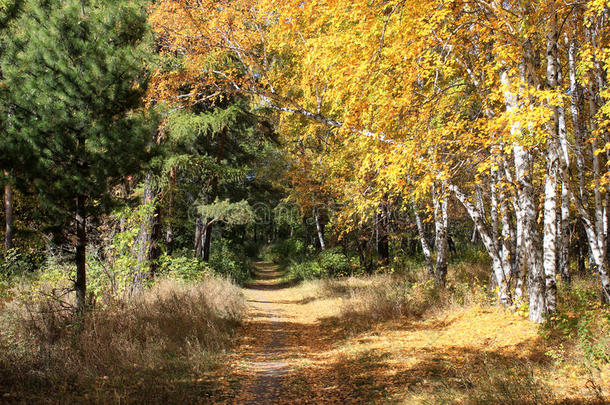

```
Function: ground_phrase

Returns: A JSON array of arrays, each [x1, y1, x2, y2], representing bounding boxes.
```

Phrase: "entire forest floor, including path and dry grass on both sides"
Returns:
[[0, 262, 610, 405]]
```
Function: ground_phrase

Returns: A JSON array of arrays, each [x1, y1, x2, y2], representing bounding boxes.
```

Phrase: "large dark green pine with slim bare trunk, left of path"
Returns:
[[2, 0, 155, 312]]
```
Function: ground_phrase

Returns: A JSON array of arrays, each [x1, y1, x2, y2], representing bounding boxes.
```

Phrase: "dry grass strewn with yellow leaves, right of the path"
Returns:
[[280, 265, 610, 405]]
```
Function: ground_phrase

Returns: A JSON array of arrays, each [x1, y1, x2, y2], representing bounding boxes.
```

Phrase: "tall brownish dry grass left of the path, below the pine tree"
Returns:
[[0, 277, 245, 403]]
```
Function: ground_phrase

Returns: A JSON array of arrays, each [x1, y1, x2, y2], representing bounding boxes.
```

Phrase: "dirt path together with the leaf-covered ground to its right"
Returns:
[[214, 263, 610, 404]]
